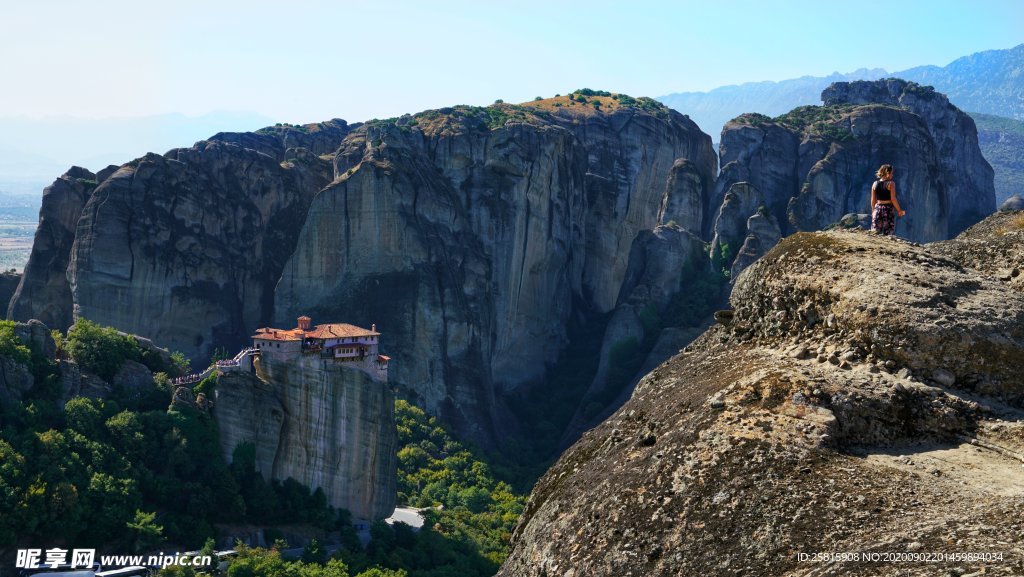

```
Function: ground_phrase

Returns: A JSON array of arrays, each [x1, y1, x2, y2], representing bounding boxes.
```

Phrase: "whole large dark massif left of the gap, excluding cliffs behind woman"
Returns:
[[18, 96, 717, 437]]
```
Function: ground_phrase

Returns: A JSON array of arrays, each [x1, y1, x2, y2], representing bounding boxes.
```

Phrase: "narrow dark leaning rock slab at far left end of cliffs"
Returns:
[[7, 166, 99, 330]]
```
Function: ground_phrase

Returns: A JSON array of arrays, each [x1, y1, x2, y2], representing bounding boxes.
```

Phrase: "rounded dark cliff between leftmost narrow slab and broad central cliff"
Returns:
[[68, 140, 330, 361]]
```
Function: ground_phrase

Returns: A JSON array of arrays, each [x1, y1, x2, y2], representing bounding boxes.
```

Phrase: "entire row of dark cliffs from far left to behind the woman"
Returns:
[[9, 81, 994, 444]]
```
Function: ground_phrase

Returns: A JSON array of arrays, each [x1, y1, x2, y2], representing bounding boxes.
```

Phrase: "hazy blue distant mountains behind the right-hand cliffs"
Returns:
[[657, 44, 1024, 141]]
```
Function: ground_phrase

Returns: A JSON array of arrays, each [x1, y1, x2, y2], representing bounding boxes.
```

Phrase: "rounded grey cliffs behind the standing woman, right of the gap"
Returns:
[[708, 79, 995, 276]]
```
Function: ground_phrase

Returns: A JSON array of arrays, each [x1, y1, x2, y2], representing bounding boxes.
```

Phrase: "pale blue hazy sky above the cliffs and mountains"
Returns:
[[0, 0, 1024, 122]]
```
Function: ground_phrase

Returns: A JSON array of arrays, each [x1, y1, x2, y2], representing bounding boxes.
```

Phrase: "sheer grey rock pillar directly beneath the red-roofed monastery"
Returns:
[[214, 355, 397, 520]]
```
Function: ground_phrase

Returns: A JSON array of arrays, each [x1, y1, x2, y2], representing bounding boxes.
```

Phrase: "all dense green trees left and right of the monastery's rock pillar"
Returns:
[[0, 321, 524, 577]]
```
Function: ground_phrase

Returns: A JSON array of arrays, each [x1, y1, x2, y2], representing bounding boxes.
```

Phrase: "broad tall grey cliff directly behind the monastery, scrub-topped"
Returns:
[[274, 98, 716, 428]]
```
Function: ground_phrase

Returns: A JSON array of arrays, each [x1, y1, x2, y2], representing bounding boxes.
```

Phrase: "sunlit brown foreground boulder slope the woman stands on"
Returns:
[[500, 213, 1024, 577]]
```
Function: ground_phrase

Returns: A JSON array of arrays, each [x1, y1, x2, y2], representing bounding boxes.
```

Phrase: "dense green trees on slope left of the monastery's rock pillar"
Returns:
[[0, 321, 339, 550]]
